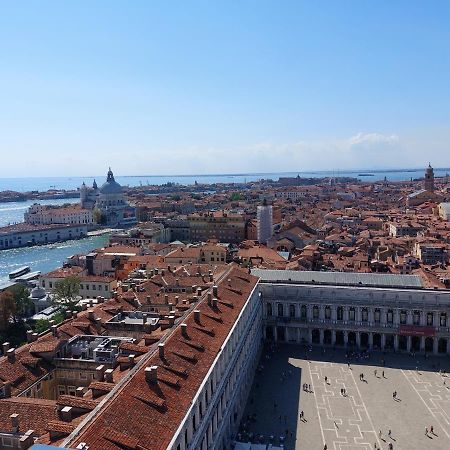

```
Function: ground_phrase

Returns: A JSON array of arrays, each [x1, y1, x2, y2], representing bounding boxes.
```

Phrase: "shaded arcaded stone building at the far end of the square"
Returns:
[[252, 270, 450, 354]]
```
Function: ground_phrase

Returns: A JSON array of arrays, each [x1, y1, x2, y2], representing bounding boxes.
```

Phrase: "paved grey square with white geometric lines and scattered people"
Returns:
[[240, 345, 450, 450]]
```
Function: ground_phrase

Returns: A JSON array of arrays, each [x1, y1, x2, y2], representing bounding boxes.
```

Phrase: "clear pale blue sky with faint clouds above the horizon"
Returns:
[[0, 0, 450, 177]]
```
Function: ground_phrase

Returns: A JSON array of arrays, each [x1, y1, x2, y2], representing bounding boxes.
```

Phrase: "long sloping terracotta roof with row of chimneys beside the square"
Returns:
[[70, 269, 257, 450]]
